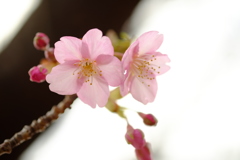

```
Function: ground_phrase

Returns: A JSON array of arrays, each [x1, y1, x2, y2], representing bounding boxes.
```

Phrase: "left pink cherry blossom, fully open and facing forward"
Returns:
[[46, 29, 123, 108]]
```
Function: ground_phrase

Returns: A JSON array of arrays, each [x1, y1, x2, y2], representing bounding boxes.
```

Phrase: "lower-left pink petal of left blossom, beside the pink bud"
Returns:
[[46, 62, 83, 95]]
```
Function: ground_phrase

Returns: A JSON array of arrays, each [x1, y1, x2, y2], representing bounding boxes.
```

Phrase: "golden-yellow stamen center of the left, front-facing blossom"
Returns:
[[73, 58, 102, 85]]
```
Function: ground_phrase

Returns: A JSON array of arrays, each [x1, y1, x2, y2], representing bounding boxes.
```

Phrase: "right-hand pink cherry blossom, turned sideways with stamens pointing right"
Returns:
[[121, 31, 170, 104]]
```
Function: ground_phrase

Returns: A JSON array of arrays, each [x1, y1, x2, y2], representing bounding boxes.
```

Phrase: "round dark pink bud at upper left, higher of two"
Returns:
[[33, 32, 50, 51]]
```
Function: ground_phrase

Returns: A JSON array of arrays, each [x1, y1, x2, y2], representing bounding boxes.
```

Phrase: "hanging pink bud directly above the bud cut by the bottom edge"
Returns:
[[125, 124, 146, 149]]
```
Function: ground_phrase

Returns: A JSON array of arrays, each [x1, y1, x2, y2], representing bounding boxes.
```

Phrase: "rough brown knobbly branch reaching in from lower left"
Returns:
[[0, 95, 77, 156]]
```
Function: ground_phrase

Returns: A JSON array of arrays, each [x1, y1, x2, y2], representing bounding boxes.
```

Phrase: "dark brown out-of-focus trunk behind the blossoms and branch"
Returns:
[[0, 0, 139, 160]]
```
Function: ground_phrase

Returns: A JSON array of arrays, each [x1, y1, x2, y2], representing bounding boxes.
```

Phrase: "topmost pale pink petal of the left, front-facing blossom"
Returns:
[[82, 29, 114, 60]]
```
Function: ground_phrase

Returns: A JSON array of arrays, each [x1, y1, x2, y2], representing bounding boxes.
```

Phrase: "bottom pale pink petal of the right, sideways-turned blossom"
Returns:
[[130, 77, 158, 104]]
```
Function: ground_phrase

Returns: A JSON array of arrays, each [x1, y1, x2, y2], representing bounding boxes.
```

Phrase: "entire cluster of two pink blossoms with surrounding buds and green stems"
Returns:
[[29, 29, 170, 160]]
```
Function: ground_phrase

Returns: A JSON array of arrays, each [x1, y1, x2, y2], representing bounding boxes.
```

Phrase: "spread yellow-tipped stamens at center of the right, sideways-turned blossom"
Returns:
[[132, 55, 160, 87]]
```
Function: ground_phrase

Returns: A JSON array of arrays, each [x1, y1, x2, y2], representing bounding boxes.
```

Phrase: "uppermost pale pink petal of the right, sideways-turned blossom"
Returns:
[[136, 31, 163, 55]]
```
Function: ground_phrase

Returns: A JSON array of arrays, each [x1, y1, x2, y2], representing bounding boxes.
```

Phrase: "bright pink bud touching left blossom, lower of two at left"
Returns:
[[28, 65, 47, 83]]
